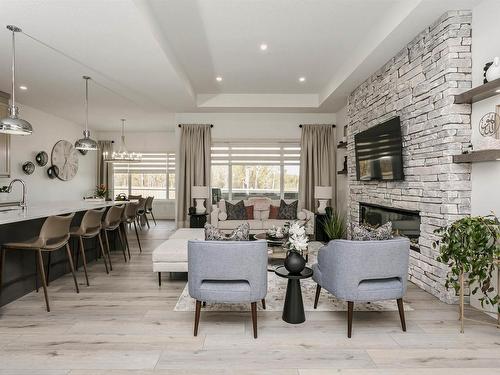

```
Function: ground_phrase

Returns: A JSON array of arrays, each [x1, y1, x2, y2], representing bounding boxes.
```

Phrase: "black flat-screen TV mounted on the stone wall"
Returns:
[[354, 117, 404, 181]]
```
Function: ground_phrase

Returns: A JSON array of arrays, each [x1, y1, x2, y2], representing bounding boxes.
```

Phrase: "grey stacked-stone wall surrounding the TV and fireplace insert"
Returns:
[[347, 11, 472, 302]]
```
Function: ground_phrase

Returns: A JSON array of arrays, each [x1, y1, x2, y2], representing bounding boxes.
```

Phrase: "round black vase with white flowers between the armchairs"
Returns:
[[283, 221, 309, 273]]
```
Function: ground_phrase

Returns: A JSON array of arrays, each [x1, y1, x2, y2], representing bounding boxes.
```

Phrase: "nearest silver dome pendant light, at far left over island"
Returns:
[[0, 25, 33, 135]]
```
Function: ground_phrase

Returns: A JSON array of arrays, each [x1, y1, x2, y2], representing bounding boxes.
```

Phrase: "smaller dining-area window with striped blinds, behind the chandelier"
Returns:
[[113, 153, 175, 199]]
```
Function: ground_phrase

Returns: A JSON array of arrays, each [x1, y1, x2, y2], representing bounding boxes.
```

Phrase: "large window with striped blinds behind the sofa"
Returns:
[[211, 142, 300, 199]]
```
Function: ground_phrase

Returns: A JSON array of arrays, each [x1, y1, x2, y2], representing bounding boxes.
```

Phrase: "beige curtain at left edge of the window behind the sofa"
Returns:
[[177, 124, 212, 228]]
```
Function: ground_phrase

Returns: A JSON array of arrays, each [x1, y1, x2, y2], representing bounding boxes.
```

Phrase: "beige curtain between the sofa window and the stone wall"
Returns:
[[299, 124, 336, 212]]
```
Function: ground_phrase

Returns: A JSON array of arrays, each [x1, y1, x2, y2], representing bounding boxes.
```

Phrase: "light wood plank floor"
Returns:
[[0, 221, 500, 375]]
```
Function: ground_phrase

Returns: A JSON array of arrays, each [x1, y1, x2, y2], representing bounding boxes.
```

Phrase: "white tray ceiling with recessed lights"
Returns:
[[0, 0, 479, 130]]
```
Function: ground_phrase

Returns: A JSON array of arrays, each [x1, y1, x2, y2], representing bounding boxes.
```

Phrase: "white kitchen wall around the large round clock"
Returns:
[[0, 105, 96, 203]]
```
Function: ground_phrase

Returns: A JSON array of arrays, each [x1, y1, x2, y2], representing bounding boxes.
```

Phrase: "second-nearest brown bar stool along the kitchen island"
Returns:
[[69, 207, 109, 286]]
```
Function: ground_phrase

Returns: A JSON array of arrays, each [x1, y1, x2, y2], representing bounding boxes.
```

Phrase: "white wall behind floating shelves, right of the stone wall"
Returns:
[[471, 0, 500, 316]]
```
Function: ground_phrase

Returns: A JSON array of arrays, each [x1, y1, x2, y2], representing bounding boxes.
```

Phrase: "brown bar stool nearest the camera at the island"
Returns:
[[0, 213, 80, 312]]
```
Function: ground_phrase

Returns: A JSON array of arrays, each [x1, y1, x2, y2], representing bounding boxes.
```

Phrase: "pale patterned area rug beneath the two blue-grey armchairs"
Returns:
[[174, 242, 413, 311]]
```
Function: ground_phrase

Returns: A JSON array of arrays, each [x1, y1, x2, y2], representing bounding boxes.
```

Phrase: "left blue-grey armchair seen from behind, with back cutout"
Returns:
[[188, 241, 267, 338]]
